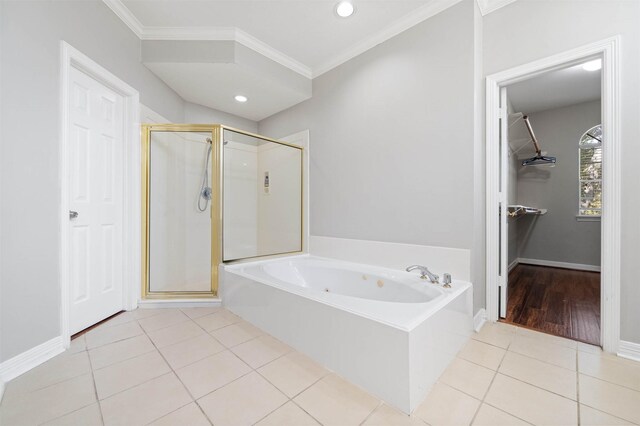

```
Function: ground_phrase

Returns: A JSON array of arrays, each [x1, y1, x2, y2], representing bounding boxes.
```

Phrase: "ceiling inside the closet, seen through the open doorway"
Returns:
[[507, 60, 601, 114]]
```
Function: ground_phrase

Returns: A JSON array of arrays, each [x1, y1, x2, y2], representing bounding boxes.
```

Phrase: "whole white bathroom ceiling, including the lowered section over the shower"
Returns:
[[103, 0, 515, 121]]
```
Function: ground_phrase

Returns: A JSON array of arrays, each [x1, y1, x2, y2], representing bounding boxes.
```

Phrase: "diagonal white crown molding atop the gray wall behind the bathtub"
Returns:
[[313, 0, 462, 78]]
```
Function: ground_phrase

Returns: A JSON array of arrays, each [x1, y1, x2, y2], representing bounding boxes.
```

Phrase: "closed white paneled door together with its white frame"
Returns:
[[60, 41, 139, 347]]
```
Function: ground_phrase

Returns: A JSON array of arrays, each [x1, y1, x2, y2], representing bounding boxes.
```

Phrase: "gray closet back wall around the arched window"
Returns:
[[509, 101, 606, 266]]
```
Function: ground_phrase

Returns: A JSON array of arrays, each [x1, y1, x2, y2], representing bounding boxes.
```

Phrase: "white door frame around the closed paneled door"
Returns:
[[59, 40, 141, 348]]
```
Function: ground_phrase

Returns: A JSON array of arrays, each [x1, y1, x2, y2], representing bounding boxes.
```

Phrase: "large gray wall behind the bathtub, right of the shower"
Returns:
[[259, 0, 475, 251]]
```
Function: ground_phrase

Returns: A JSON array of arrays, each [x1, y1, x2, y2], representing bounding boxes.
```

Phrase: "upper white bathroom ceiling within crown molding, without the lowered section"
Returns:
[[122, 0, 451, 74]]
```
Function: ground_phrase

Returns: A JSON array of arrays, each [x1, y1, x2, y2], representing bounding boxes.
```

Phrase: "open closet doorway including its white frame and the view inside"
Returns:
[[486, 38, 620, 352]]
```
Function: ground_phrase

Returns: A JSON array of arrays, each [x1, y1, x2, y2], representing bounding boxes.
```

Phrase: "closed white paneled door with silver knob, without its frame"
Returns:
[[68, 67, 124, 334]]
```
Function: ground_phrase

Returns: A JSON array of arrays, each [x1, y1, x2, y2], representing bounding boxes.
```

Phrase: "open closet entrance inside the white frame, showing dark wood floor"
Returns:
[[500, 65, 603, 345]]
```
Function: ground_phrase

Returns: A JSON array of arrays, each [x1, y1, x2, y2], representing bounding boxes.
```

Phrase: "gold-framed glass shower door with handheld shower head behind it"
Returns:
[[143, 125, 219, 298]]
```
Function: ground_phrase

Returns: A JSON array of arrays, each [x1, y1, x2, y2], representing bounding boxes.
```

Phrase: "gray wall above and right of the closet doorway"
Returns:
[[483, 0, 640, 342]]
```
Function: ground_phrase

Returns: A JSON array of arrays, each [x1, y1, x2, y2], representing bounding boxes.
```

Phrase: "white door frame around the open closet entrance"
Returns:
[[485, 35, 622, 353]]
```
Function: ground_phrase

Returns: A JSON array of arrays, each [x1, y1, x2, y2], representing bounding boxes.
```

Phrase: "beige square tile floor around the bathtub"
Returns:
[[0, 308, 640, 426]]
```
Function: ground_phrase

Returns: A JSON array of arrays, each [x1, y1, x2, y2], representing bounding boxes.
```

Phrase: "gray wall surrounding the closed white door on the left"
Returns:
[[0, 1, 178, 361]]
